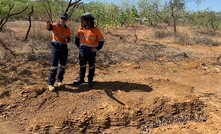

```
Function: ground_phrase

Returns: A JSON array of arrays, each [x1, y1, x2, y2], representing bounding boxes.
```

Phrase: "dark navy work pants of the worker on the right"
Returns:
[[79, 46, 96, 82]]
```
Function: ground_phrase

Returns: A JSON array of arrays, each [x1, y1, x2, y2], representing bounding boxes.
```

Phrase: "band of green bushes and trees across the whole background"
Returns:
[[0, 0, 221, 30]]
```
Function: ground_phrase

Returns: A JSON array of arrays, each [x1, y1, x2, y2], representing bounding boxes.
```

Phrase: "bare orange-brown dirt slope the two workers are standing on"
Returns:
[[0, 23, 221, 134]]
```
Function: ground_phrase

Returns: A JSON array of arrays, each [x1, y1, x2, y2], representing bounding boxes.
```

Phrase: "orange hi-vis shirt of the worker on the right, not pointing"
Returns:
[[76, 27, 104, 47]]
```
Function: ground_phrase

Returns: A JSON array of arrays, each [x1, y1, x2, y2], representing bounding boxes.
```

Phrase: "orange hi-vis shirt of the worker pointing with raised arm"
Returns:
[[52, 23, 71, 44]]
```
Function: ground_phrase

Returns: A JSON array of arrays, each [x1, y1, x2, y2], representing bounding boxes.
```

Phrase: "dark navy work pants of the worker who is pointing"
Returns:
[[48, 44, 68, 85]]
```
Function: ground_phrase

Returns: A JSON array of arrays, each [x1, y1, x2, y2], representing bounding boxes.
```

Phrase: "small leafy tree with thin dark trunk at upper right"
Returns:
[[138, 0, 201, 33]]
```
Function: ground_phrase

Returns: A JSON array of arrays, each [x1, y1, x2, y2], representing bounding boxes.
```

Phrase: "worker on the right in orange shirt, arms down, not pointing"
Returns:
[[73, 13, 104, 87]]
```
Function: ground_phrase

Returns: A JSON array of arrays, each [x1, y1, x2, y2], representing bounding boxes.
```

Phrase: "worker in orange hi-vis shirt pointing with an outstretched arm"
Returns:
[[46, 13, 71, 91]]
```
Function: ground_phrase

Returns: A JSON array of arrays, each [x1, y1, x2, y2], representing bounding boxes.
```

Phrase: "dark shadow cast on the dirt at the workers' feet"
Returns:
[[57, 81, 153, 105]]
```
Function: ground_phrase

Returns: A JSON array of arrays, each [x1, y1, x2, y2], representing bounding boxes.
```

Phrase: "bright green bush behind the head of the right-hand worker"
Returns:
[[80, 2, 138, 27]]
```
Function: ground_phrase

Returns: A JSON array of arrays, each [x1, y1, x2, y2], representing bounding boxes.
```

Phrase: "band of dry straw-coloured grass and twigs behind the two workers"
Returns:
[[1, 22, 220, 65]]
